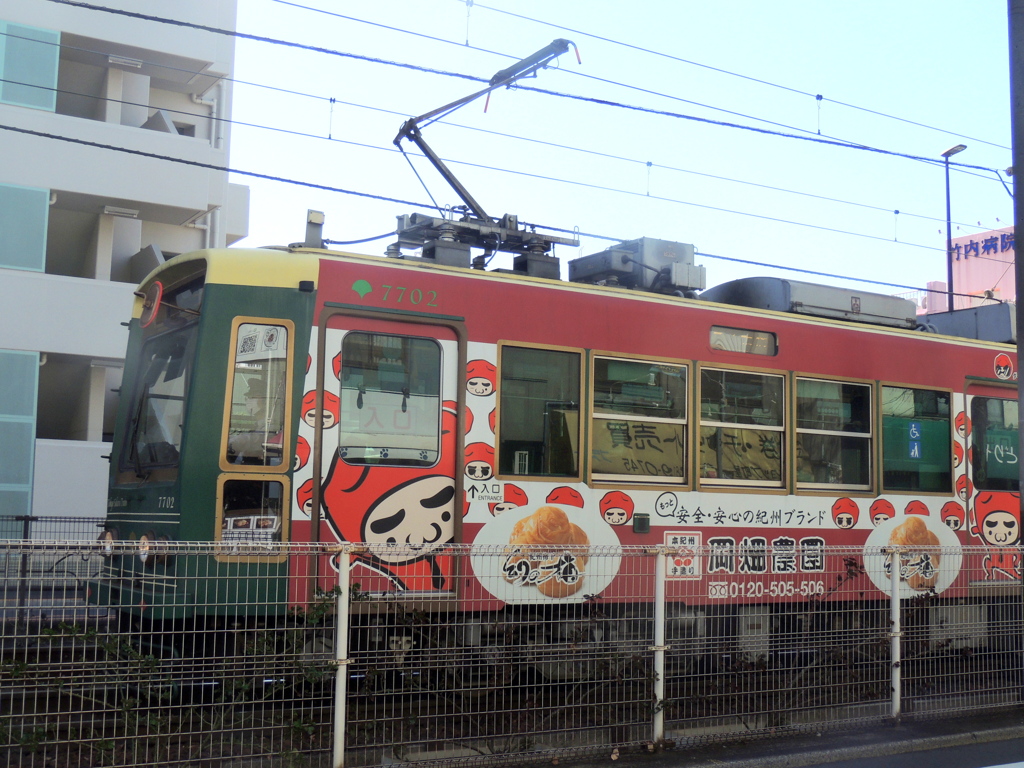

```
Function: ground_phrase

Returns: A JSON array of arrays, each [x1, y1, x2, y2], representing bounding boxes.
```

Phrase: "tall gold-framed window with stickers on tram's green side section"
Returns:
[[224, 323, 289, 467]]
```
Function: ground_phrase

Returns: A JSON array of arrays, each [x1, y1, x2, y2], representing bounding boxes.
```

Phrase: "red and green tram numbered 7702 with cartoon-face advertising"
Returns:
[[89, 215, 1021, 667]]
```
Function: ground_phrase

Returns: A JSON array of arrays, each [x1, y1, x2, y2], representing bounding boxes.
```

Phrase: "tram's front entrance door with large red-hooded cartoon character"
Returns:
[[322, 315, 461, 592]]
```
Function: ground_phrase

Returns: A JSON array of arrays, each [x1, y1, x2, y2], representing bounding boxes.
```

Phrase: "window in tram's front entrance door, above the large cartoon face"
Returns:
[[338, 331, 441, 467]]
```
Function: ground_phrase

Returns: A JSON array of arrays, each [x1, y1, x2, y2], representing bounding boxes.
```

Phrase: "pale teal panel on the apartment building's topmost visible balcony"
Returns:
[[0, 22, 60, 112]]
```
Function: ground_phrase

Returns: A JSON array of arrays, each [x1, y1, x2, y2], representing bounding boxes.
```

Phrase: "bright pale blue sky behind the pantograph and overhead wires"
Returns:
[[230, 0, 1013, 293]]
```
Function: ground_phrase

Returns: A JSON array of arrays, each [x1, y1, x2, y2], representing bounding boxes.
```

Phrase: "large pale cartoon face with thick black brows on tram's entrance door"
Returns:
[[362, 475, 455, 565]]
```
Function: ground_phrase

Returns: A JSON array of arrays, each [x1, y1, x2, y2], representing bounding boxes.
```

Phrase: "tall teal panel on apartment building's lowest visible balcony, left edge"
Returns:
[[0, 349, 39, 517]]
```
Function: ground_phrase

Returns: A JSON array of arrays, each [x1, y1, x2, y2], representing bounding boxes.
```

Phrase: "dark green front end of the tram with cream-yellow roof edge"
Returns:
[[89, 250, 315, 622]]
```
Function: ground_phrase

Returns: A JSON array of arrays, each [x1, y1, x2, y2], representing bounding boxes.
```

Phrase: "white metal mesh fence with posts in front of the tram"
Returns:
[[0, 538, 1022, 768]]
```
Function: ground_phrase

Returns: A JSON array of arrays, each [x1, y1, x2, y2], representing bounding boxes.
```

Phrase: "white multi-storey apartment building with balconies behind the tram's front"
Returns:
[[0, 0, 249, 536]]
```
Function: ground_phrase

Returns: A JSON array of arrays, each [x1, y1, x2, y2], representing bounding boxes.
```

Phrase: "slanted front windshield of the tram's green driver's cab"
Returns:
[[121, 323, 198, 474]]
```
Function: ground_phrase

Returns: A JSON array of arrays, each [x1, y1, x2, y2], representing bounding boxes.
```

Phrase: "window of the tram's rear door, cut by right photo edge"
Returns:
[[971, 397, 1020, 492]]
